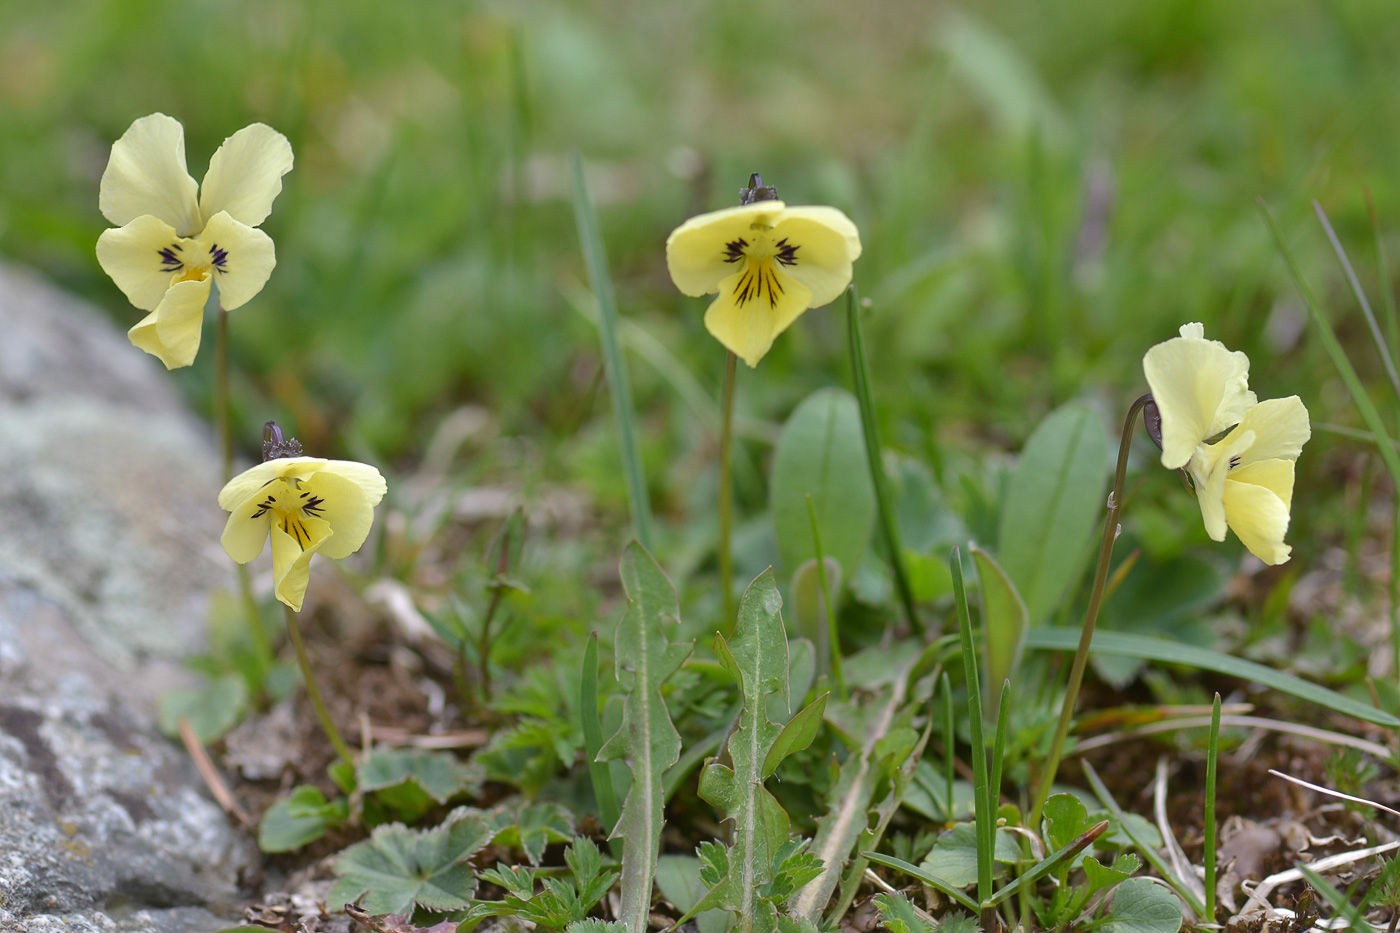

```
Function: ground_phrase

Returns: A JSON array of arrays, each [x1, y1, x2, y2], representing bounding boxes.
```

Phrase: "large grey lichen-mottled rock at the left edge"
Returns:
[[0, 265, 258, 933]]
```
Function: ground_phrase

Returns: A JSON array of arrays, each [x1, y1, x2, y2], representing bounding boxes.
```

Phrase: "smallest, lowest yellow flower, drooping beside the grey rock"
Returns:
[[218, 457, 386, 612]]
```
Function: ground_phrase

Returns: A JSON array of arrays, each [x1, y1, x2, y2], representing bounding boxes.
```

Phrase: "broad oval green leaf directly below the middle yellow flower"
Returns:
[[770, 388, 875, 580]]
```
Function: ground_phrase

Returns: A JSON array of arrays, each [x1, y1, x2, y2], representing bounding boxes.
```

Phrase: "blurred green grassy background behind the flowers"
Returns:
[[0, 0, 1400, 574]]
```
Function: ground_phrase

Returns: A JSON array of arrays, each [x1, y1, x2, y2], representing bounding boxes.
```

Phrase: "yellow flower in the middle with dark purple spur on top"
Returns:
[[666, 175, 861, 367]]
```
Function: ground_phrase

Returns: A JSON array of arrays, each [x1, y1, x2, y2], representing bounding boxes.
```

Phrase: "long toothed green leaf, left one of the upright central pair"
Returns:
[[598, 542, 692, 933]]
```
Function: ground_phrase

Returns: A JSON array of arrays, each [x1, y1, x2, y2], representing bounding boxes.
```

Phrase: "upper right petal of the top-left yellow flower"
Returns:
[[199, 123, 293, 228]]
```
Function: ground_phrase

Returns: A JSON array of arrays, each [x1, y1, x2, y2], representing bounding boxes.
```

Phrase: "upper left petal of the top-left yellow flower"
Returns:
[[98, 113, 204, 237]]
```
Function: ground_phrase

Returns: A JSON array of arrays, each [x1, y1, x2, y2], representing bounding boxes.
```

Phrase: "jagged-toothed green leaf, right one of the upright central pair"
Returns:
[[696, 570, 825, 933]]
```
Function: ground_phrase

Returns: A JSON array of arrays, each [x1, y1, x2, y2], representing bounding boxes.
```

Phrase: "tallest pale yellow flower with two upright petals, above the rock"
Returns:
[[97, 113, 293, 370]]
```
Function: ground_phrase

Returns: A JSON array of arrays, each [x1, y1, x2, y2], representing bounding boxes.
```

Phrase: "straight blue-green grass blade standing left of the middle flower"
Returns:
[[568, 153, 652, 551]]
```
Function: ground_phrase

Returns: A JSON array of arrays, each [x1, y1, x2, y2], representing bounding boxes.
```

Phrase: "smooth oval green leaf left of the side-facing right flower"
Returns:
[[997, 405, 1109, 624]]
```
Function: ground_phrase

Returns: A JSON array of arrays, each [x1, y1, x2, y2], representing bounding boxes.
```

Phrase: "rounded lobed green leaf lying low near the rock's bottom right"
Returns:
[[326, 807, 491, 915]]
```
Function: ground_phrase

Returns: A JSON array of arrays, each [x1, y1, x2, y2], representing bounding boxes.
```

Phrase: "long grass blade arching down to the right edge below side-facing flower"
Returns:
[[1026, 626, 1400, 728]]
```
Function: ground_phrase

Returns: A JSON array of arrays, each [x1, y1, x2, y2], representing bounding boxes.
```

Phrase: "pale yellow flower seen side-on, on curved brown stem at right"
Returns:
[[1142, 324, 1312, 565]]
